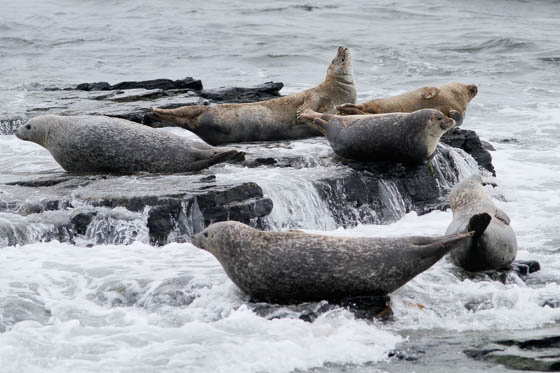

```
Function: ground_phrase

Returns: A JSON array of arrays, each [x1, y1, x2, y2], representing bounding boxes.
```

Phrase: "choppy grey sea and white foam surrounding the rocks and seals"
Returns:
[[0, 0, 560, 372]]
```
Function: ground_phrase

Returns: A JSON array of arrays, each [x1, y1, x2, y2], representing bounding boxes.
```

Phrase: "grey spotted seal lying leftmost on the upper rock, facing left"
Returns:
[[16, 115, 244, 173]]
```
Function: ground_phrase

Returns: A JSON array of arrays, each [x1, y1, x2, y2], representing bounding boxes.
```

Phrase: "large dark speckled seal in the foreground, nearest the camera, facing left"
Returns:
[[192, 221, 473, 304]]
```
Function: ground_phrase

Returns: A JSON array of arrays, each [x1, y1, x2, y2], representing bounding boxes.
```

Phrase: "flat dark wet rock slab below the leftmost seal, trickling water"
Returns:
[[0, 175, 272, 245]]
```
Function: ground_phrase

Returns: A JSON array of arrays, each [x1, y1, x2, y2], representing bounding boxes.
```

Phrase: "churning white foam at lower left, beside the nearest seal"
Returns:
[[0, 242, 402, 372]]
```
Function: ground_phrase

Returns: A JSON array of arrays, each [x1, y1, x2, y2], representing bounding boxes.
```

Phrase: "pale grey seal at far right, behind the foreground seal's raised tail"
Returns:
[[447, 174, 517, 271]]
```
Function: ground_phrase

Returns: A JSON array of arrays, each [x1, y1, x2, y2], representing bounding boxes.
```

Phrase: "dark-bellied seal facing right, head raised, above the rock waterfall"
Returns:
[[301, 109, 455, 164]]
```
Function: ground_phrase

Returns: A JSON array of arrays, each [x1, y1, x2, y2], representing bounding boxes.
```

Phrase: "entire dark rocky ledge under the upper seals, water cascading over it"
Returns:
[[0, 78, 493, 246]]
